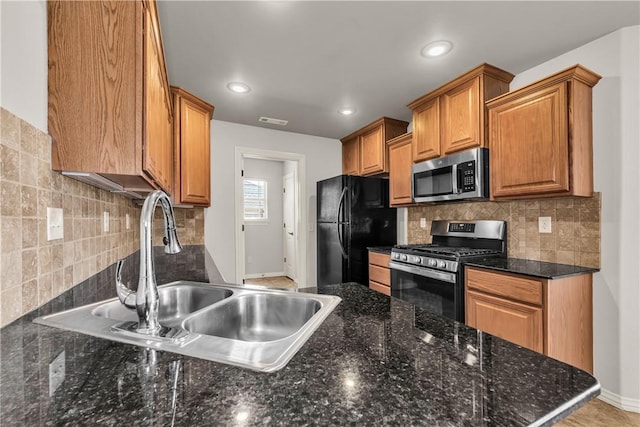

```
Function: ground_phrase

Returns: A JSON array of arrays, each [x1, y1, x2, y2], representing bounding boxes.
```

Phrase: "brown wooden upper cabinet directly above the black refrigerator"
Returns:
[[341, 117, 409, 176]]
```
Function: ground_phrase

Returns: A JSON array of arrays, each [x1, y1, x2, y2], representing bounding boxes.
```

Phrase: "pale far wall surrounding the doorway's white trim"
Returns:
[[204, 120, 342, 286]]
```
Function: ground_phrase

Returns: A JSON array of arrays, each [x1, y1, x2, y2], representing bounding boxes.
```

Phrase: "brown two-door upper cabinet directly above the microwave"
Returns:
[[407, 64, 514, 162]]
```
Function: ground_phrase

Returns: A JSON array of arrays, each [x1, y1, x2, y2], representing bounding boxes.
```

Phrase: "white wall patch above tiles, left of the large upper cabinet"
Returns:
[[0, 0, 47, 132]]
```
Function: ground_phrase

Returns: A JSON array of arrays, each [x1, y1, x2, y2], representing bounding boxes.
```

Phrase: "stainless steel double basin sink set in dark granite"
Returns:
[[34, 281, 341, 372]]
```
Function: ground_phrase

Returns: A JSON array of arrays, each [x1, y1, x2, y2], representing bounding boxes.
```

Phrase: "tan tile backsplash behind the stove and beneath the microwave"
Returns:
[[407, 193, 602, 268]]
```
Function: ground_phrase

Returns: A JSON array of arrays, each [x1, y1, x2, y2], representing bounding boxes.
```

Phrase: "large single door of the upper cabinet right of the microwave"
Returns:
[[489, 83, 570, 199]]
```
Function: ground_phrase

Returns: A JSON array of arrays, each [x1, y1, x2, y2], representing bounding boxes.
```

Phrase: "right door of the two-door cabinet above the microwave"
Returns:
[[441, 77, 484, 154]]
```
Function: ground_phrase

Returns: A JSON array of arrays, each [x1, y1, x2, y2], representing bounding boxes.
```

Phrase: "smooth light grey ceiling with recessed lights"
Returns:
[[158, 0, 640, 139]]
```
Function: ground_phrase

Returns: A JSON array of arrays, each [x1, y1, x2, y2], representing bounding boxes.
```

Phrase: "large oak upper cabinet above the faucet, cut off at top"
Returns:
[[47, 0, 173, 197]]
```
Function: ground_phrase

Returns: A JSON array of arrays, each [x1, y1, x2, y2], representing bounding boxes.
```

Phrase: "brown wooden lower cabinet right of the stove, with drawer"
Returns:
[[465, 267, 593, 373]]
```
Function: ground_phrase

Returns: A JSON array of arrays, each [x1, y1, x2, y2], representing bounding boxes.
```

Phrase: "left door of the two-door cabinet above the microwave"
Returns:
[[413, 98, 440, 162]]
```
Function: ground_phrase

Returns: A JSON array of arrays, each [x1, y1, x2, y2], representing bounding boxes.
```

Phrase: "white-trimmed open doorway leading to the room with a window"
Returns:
[[235, 147, 307, 288]]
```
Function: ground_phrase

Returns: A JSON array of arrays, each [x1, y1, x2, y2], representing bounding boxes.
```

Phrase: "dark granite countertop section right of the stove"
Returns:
[[465, 258, 600, 279]]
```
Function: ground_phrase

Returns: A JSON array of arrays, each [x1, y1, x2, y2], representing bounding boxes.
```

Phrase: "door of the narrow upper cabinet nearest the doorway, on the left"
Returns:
[[176, 98, 211, 206]]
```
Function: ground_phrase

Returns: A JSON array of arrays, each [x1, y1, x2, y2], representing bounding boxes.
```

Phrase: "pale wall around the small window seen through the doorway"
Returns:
[[244, 159, 284, 275]]
